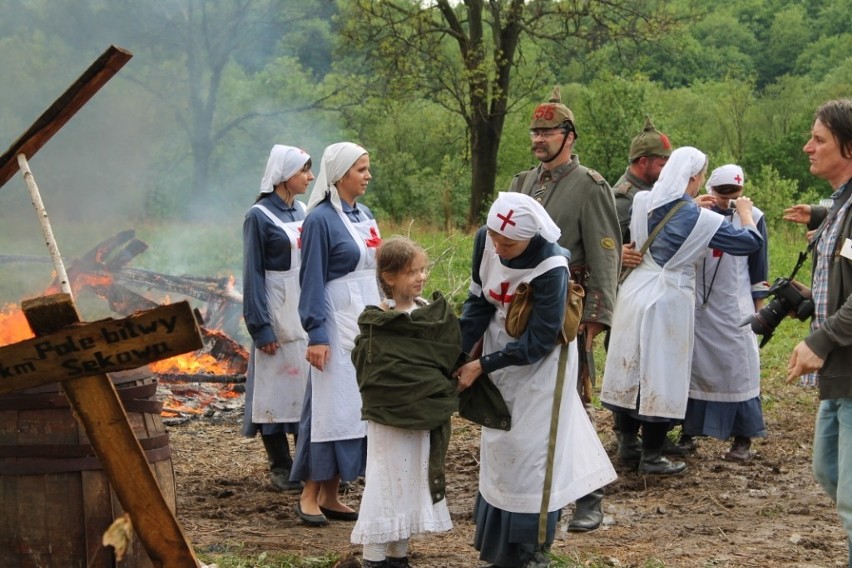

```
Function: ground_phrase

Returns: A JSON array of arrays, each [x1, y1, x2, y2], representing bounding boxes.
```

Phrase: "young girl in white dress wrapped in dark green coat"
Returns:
[[351, 238, 461, 568]]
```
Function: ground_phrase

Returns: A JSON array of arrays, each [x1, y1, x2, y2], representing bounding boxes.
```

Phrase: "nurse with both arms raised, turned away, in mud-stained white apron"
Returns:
[[600, 146, 763, 475]]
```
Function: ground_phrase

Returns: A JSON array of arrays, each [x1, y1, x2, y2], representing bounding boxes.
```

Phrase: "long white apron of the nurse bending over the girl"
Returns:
[[479, 238, 616, 513]]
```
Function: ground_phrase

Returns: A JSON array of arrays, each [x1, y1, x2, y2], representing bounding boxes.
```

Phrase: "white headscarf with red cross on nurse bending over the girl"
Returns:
[[487, 191, 562, 243]]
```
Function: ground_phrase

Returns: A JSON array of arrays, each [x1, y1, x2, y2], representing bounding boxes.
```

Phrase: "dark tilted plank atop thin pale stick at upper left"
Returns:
[[0, 45, 133, 187]]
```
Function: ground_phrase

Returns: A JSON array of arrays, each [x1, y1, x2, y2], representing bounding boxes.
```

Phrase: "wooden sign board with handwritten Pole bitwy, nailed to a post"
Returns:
[[0, 301, 203, 394]]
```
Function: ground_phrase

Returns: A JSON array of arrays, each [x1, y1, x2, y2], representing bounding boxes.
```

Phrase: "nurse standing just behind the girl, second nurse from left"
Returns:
[[291, 142, 381, 526]]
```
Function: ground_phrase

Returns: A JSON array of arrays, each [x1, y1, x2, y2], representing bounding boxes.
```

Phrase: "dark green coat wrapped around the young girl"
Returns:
[[352, 292, 462, 502]]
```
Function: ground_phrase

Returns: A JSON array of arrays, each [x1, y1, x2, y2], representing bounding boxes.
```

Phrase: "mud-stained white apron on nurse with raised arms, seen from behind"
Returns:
[[600, 191, 724, 419]]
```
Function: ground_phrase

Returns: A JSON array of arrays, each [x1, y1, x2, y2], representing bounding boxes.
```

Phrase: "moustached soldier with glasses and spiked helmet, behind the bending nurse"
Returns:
[[510, 87, 621, 532]]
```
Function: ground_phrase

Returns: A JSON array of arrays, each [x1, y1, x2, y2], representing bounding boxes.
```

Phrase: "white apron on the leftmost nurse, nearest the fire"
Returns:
[[251, 202, 310, 424]]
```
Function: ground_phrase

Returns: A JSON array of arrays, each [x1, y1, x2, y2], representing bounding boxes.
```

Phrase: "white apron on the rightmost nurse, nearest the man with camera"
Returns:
[[689, 208, 763, 402]]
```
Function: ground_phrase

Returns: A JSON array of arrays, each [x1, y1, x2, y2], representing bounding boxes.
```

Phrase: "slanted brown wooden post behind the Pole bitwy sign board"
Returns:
[[22, 294, 200, 568]]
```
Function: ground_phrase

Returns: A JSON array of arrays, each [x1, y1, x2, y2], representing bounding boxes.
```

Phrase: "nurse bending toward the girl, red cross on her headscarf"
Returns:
[[457, 192, 615, 568]]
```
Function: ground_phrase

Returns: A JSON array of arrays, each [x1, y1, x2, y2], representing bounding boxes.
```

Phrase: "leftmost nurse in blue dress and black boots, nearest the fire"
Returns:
[[243, 144, 314, 491]]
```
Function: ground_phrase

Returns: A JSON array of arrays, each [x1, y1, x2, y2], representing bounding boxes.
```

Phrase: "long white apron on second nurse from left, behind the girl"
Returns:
[[311, 211, 381, 442]]
